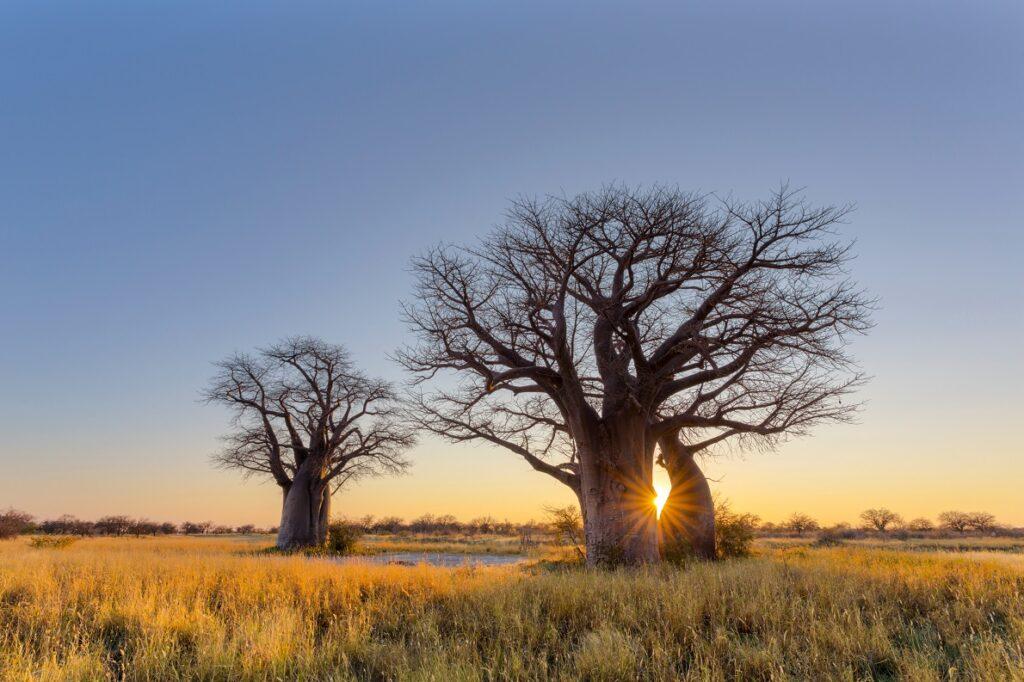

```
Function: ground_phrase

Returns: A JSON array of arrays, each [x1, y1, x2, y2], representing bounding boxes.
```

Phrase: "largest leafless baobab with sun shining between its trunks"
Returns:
[[398, 187, 870, 564]]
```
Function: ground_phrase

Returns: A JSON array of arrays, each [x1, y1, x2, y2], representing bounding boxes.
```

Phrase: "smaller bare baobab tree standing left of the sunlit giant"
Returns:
[[205, 337, 414, 549]]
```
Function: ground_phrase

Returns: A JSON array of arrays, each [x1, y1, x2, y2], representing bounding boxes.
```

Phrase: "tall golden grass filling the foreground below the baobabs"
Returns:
[[0, 539, 1024, 680]]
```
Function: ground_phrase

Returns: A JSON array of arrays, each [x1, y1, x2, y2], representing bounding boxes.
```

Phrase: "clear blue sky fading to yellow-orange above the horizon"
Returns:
[[0, 0, 1024, 524]]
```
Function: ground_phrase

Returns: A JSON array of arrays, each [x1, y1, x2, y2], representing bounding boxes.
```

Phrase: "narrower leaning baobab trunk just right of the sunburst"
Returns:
[[659, 436, 716, 559]]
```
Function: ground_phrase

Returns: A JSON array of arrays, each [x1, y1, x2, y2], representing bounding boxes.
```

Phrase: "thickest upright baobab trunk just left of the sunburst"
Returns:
[[580, 416, 660, 566]]
